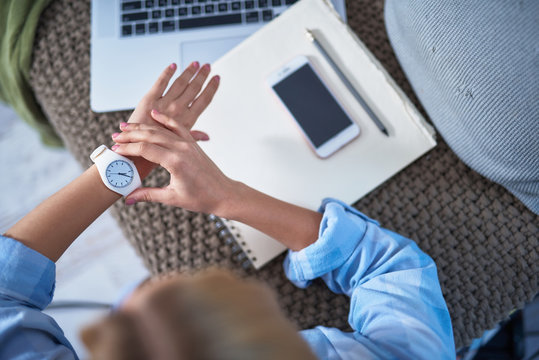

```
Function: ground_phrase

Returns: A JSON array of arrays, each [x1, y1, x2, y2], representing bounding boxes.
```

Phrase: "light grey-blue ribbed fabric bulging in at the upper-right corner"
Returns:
[[385, 0, 539, 214]]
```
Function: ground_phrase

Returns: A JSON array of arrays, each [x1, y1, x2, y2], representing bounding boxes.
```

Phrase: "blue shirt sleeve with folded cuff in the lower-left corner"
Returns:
[[0, 236, 77, 359]]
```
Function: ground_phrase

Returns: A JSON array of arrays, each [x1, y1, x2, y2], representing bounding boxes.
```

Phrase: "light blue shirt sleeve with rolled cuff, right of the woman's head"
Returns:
[[284, 199, 455, 359]]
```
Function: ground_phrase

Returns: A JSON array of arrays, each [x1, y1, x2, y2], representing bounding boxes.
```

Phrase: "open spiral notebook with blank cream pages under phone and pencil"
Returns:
[[195, 0, 436, 269]]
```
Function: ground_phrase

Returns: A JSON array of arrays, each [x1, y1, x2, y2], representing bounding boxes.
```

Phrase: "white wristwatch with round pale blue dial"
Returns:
[[90, 145, 142, 196]]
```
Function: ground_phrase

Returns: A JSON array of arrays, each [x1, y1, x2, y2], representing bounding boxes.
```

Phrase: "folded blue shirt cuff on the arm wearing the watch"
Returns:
[[0, 236, 56, 310]]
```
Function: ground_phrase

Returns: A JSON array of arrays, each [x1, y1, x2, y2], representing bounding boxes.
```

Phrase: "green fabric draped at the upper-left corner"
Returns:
[[0, 0, 63, 146]]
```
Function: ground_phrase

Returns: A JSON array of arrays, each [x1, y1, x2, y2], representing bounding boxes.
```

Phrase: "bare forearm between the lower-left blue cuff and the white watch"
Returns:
[[5, 165, 120, 261]]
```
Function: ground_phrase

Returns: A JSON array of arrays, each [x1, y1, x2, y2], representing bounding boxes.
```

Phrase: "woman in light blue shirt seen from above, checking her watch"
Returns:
[[0, 62, 455, 359]]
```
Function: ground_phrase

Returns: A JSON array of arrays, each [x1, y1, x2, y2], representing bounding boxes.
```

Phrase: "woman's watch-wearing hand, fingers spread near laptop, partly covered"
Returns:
[[124, 61, 220, 178]]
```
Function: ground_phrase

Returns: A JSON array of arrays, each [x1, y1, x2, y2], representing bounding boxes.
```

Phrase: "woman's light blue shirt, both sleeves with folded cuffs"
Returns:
[[0, 199, 455, 359]]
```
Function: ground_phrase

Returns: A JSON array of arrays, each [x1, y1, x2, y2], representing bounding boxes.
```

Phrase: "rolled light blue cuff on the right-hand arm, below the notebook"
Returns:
[[284, 198, 378, 287]]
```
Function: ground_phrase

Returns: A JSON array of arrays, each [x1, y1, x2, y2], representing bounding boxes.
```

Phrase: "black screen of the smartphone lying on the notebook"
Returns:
[[273, 64, 352, 147]]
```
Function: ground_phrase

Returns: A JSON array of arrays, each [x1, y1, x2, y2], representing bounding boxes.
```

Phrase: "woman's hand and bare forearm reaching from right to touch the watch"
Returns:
[[112, 110, 322, 251]]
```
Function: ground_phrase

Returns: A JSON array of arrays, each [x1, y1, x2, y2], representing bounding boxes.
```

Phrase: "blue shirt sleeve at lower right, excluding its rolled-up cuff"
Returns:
[[342, 228, 455, 359]]
